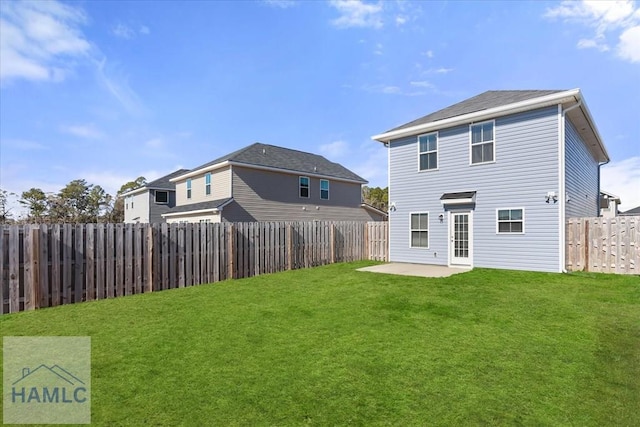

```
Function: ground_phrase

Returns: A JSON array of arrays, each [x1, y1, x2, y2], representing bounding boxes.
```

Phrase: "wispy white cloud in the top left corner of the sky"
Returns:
[[0, 1, 92, 81]]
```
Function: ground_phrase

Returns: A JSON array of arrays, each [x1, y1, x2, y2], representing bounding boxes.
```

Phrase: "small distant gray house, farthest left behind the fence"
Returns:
[[120, 169, 188, 223]]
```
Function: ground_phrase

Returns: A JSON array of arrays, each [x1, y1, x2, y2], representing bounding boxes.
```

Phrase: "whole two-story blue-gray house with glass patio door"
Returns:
[[373, 89, 609, 272]]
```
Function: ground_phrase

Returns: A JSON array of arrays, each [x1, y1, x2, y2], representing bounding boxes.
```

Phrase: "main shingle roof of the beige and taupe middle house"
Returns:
[[192, 142, 367, 184]]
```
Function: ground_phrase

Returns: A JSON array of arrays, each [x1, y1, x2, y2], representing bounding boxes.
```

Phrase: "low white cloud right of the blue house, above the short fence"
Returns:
[[600, 156, 640, 211]]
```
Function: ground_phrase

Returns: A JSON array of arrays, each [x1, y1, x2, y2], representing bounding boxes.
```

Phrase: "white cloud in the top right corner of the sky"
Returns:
[[544, 0, 640, 62]]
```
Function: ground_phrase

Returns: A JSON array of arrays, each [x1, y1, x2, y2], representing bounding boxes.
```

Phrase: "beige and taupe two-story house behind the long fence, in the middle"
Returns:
[[162, 143, 386, 223]]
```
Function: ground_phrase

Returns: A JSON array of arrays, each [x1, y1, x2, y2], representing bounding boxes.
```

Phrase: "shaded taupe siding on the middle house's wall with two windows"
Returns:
[[222, 166, 380, 222]]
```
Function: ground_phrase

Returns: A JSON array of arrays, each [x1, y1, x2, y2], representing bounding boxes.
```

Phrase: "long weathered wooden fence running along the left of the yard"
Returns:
[[0, 222, 387, 314]]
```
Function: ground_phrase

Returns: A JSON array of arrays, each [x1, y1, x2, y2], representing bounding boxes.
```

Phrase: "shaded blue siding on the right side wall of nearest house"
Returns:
[[565, 119, 600, 218]]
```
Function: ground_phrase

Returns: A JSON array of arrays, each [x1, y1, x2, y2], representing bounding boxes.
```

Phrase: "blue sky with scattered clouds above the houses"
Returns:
[[0, 0, 640, 214]]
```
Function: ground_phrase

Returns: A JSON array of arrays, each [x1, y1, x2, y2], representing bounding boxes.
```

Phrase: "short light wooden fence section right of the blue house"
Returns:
[[566, 216, 640, 274]]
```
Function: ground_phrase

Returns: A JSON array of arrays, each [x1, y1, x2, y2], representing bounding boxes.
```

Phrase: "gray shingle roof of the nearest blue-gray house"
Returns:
[[387, 90, 564, 132]]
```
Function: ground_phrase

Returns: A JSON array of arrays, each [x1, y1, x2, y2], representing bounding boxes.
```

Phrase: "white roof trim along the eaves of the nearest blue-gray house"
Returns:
[[371, 89, 584, 143]]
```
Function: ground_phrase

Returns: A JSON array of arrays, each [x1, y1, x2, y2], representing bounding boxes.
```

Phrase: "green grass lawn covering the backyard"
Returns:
[[0, 262, 640, 426]]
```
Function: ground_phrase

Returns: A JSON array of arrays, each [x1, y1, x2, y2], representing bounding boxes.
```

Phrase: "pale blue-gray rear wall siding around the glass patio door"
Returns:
[[389, 107, 560, 271]]
